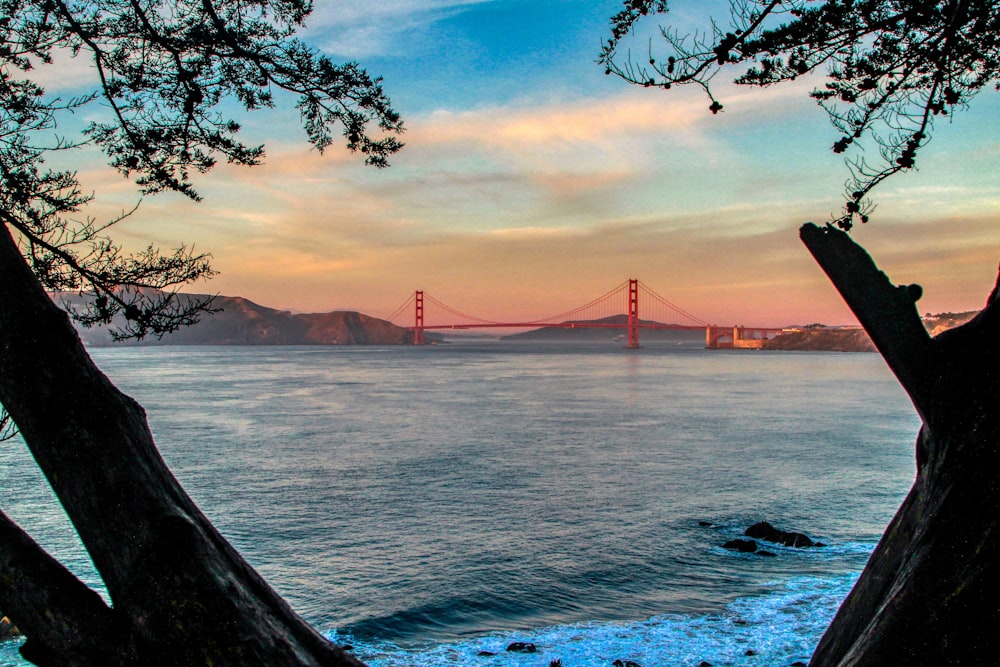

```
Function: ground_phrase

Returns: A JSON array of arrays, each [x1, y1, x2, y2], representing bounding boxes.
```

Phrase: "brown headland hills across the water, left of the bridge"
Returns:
[[54, 294, 441, 346]]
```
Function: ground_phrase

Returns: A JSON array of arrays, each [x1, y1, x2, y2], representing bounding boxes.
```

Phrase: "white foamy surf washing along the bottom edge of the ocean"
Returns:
[[331, 574, 857, 667]]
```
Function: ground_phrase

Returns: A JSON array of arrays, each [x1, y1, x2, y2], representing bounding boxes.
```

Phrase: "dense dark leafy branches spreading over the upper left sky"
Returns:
[[0, 0, 403, 338]]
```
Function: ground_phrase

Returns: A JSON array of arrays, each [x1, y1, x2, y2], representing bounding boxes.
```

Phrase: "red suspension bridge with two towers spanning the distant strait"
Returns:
[[386, 278, 782, 349]]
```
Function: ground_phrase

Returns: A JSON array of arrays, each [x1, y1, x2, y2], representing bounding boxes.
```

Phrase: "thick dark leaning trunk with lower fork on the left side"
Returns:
[[0, 222, 361, 667]]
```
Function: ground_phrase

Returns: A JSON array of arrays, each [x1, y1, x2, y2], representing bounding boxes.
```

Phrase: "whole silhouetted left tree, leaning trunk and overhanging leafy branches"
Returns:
[[0, 0, 403, 666]]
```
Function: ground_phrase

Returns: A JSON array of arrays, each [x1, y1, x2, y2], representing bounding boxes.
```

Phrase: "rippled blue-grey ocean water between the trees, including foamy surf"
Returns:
[[0, 341, 919, 667]]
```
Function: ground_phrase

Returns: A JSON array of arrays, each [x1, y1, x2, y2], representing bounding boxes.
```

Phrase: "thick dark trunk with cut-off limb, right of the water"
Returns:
[[801, 225, 1000, 667]]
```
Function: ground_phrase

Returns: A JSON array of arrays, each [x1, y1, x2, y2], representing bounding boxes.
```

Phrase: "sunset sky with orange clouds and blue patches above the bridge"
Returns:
[[37, 0, 1000, 326]]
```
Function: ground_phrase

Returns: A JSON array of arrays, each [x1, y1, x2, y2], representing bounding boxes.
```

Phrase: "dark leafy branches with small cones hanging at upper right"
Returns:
[[600, 0, 1000, 230]]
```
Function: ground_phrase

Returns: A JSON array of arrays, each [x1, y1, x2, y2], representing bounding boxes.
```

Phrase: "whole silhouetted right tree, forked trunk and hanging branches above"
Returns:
[[600, 0, 1000, 665]]
